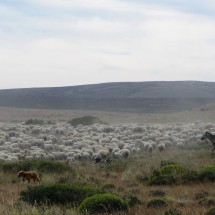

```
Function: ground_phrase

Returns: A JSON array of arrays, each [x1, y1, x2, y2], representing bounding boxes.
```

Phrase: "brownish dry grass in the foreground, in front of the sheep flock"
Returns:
[[0, 141, 215, 215]]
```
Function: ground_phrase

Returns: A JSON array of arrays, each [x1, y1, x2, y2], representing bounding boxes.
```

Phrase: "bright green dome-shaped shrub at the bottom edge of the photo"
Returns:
[[78, 194, 128, 214]]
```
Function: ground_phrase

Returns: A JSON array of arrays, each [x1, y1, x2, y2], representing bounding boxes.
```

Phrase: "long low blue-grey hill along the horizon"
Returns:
[[0, 81, 215, 113]]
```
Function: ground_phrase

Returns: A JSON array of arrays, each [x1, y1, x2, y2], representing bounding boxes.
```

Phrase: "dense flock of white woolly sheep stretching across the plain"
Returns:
[[0, 122, 212, 164]]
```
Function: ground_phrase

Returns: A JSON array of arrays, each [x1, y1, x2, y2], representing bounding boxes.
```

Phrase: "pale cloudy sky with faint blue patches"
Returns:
[[0, 0, 215, 89]]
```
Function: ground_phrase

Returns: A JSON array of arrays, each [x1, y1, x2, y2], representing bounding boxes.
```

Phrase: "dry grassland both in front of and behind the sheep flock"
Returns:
[[0, 108, 215, 215]]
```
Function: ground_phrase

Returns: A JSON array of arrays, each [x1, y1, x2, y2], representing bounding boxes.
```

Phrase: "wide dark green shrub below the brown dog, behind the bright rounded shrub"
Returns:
[[20, 184, 101, 205]]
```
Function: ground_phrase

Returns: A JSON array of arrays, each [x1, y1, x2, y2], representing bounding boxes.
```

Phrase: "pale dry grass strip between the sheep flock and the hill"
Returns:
[[0, 107, 215, 123]]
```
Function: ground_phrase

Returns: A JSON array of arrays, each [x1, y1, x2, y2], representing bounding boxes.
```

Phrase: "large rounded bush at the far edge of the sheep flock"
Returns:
[[68, 116, 102, 127]]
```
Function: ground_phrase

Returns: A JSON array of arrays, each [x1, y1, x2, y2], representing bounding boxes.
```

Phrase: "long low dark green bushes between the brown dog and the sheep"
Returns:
[[2, 160, 71, 173]]
